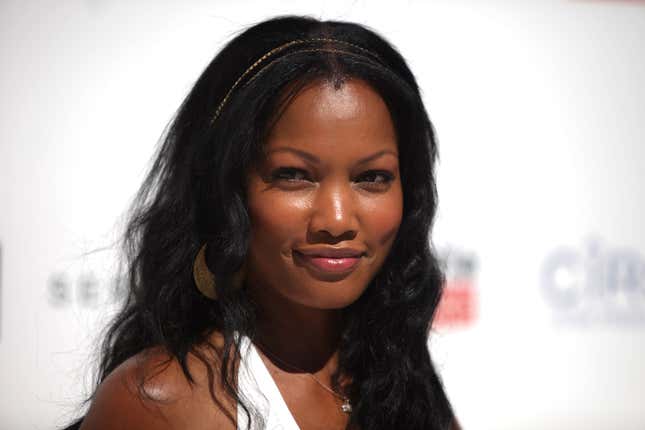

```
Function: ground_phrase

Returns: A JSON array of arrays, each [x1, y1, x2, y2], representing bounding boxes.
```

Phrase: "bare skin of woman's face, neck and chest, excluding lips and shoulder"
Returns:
[[247, 80, 403, 430]]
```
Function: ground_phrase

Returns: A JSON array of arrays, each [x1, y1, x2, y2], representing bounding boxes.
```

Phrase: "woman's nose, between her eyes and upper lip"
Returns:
[[309, 181, 358, 242]]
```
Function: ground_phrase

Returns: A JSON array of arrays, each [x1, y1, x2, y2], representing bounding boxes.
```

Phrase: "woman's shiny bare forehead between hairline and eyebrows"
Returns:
[[265, 79, 397, 157]]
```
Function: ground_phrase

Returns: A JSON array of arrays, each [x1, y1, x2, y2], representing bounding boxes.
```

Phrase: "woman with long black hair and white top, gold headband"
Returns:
[[66, 17, 456, 430]]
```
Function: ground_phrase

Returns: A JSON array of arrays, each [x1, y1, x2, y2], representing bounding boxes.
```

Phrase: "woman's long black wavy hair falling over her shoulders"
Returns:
[[63, 16, 454, 430]]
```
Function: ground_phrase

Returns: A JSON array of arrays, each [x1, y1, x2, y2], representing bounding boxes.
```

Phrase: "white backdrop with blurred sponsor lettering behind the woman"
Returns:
[[0, 0, 645, 430]]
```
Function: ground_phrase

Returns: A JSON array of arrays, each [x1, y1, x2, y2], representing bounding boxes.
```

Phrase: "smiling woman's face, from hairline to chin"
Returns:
[[247, 79, 403, 309]]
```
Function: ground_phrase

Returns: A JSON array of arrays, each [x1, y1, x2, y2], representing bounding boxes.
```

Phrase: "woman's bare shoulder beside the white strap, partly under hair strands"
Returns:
[[81, 335, 236, 430]]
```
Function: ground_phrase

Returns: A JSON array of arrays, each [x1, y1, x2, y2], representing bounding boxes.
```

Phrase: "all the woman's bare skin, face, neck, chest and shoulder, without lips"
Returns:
[[81, 79, 403, 430]]
